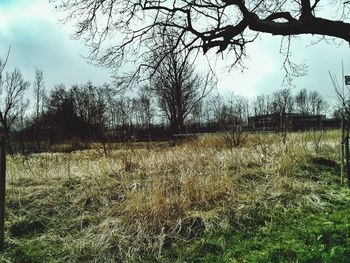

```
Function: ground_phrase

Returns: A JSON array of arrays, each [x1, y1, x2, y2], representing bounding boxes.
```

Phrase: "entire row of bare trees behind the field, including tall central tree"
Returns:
[[0, 46, 334, 155]]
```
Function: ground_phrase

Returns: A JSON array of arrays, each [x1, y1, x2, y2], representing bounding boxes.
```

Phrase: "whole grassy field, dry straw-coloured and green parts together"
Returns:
[[0, 131, 350, 262]]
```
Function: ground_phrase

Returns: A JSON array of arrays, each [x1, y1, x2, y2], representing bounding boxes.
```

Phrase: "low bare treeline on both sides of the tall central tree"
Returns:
[[11, 82, 340, 155]]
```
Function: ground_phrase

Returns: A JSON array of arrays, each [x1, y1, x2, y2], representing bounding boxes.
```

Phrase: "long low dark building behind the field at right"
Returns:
[[248, 113, 340, 131]]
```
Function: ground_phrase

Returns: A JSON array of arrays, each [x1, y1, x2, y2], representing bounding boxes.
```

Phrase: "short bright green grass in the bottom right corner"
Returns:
[[164, 188, 350, 263]]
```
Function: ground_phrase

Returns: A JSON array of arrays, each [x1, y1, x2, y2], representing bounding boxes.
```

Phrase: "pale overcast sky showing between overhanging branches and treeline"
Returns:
[[0, 0, 350, 107]]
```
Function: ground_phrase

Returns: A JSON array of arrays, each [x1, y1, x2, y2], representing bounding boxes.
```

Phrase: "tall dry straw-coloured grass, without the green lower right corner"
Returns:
[[0, 131, 348, 262]]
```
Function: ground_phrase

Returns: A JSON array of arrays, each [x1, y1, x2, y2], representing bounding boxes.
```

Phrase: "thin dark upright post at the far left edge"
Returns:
[[0, 128, 6, 252]]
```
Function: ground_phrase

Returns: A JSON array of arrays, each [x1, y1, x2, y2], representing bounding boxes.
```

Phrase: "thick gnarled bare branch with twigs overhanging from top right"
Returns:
[[52, 0, 350, 80]]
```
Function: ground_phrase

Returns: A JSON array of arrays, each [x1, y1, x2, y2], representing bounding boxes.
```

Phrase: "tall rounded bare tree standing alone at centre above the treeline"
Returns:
[[149, 46, 214, 134]]
